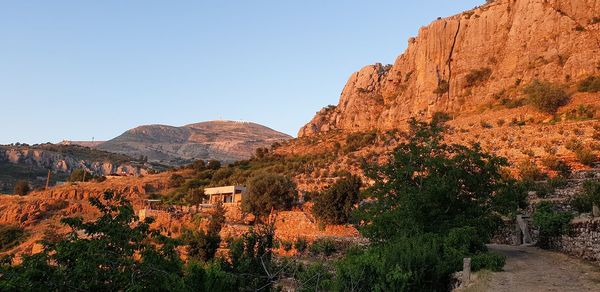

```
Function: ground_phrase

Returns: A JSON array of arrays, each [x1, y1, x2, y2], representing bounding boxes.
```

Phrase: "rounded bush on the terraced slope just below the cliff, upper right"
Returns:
[[523, 80, 569, 114]]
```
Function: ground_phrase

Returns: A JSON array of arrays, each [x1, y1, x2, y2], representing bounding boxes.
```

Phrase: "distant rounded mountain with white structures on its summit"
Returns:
[[97, 121, 292, 165]]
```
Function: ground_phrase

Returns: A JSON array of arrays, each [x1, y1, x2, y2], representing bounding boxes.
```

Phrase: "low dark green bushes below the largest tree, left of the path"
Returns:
[[335, 234, 459, 291]]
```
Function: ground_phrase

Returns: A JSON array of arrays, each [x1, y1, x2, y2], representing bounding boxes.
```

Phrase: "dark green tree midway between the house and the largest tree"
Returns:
[[312, 176, 362, 224]]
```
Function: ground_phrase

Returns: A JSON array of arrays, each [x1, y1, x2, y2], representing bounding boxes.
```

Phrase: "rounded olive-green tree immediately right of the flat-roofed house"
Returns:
[[242, 173, 296, 218]]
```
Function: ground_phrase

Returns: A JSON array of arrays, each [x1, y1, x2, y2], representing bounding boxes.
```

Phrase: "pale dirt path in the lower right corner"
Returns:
[[483, 245, 600, 292]]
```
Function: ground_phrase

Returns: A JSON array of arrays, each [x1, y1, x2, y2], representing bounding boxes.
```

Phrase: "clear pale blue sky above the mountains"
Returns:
[[0, 0, 484, 144]]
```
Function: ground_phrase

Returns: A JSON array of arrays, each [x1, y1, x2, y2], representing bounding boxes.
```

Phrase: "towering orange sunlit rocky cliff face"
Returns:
[[298, 0, 600, 137]]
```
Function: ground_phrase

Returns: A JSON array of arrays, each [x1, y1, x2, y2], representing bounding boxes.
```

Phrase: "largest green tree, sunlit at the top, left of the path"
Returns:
[[359, 120, 508, 242]]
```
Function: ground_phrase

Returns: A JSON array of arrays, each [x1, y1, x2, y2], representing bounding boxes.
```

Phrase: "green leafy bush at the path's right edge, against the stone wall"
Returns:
[[532, 202, 573, 248]]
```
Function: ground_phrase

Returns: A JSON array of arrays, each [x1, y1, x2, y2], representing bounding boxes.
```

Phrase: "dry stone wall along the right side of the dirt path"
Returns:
[[558, 218, 600, 263]]
